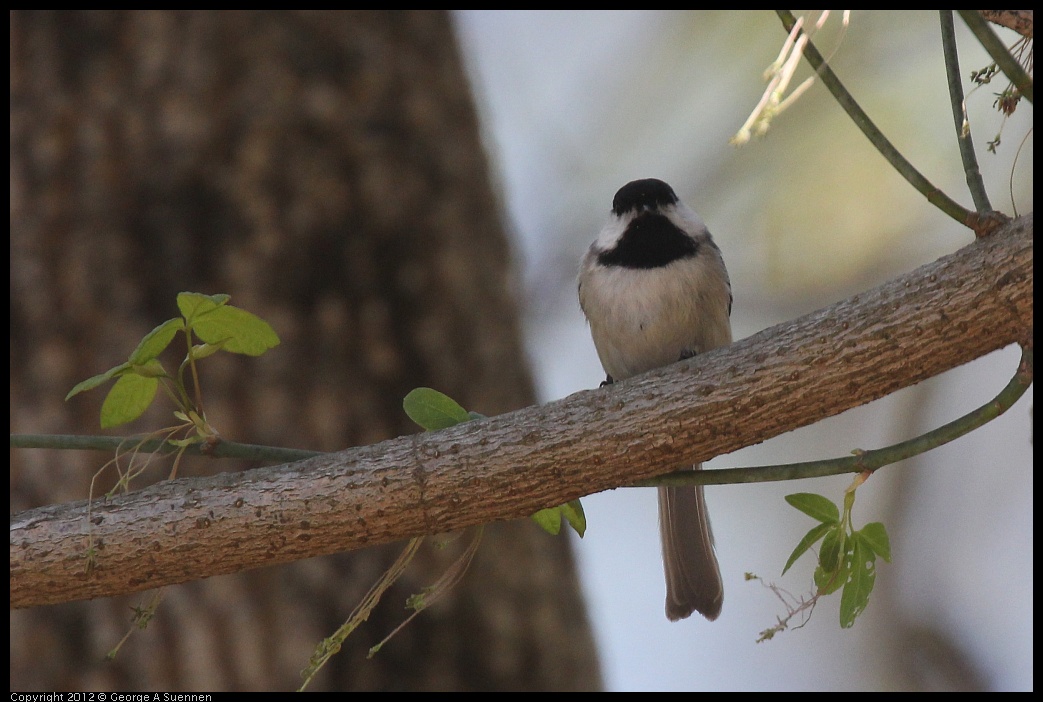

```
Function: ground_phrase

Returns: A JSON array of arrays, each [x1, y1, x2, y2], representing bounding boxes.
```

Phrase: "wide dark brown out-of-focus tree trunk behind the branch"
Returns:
[[10, 11, 600, 692]]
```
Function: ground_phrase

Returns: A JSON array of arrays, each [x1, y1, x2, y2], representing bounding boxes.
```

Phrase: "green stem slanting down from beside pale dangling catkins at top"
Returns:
[[775, 9, 977, 226]]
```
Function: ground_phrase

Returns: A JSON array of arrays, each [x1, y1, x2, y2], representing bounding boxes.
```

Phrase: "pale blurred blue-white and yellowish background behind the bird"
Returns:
[[456, 10, 1033, 691]]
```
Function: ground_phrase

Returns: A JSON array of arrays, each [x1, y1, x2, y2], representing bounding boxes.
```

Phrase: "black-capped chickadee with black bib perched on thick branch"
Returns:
[[579, 178, 731, 621]]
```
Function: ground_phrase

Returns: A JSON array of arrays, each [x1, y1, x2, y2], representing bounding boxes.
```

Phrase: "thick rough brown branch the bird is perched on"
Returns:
[[10, 214, 1033, 608]]
